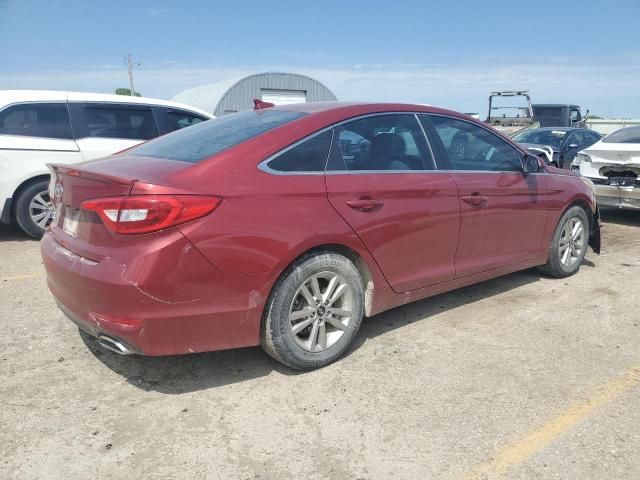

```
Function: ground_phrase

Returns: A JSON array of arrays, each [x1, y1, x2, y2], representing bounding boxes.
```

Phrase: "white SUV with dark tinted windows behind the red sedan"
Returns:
[[0, 90, 213, 238]]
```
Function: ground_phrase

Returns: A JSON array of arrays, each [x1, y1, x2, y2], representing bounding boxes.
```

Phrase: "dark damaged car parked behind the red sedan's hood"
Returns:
[[512, 127, 602, 168]]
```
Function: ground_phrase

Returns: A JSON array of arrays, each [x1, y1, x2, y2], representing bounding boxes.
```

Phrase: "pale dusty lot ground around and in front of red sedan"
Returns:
[[0, 212, 640, 480]]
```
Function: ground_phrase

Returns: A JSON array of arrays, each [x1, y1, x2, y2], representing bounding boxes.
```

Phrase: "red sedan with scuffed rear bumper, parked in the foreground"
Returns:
[[41, 103, 600, 369]]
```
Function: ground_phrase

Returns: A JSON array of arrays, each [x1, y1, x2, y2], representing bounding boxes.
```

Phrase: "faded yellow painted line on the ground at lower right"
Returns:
[[464, 365, 640, 480]]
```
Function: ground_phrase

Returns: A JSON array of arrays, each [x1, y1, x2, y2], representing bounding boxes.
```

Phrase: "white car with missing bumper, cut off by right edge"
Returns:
[[571, 126, 640, 209]]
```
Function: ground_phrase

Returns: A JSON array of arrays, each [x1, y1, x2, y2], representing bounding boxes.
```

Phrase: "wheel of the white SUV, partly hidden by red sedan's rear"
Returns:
[[15, 180, 54, 239]]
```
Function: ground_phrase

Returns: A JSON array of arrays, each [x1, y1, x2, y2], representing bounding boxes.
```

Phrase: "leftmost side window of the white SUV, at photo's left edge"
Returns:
[[0, 103, 72, 139]]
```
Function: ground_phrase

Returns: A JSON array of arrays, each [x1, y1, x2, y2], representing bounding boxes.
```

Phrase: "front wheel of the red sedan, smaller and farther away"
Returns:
[[540, 206, 589, 278]]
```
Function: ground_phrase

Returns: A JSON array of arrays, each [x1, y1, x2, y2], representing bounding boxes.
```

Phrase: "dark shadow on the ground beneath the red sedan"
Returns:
[[80, 270, 541, 395]]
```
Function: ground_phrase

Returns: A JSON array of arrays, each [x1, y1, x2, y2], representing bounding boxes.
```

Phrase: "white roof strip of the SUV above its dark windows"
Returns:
[[0, 90, 213, 118]]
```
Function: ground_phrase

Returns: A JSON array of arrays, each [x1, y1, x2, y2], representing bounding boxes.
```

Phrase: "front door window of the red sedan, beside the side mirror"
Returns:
[[430, 115, 522, 172]]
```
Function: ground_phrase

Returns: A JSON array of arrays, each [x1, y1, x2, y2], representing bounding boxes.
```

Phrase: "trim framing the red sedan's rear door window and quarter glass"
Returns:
[[258, 111, 444, 175]]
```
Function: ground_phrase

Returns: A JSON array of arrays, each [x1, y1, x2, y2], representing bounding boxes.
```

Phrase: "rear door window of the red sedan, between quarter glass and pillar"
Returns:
[[327, 114, 435, 172]]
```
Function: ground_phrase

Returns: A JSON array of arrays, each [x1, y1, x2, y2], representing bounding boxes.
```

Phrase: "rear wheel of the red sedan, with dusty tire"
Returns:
[[260, 252, 364, 370]]
